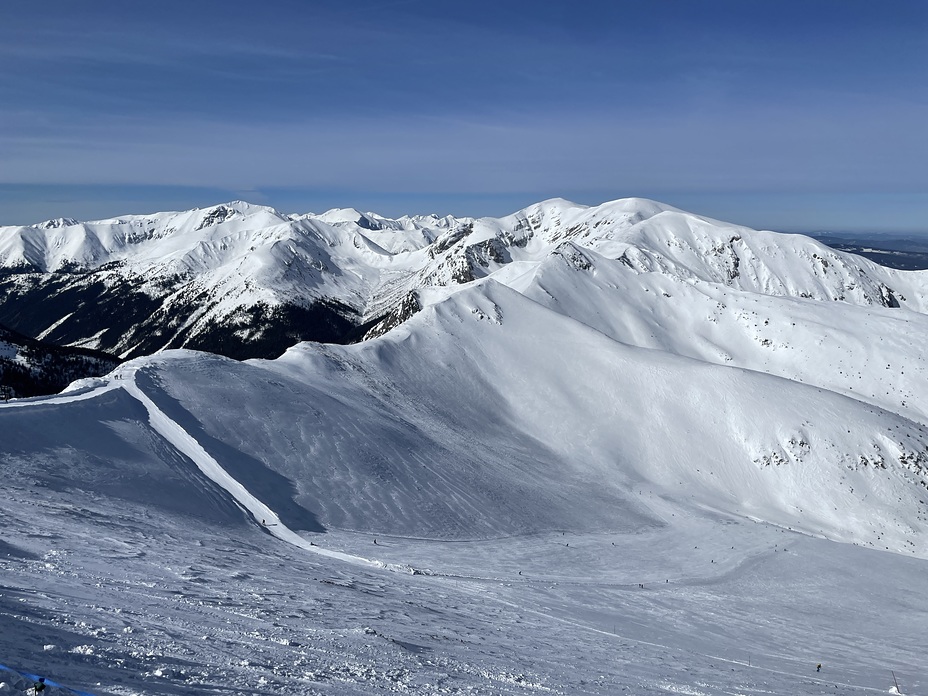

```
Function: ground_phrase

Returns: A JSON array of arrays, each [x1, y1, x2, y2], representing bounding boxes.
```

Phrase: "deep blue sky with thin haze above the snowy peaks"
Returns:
[[0, 0, 928, 232]]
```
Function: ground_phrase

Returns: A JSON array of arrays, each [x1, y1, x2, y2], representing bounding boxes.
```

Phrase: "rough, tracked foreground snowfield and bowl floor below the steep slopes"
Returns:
[[0, 480, 928, 694]]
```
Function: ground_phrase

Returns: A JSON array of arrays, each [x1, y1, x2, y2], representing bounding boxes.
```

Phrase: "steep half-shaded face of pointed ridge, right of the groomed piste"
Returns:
[[4, 283, 928, 556]]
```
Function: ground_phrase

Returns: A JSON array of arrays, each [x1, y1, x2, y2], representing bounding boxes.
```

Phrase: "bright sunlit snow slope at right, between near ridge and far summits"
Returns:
[[511, 239, 928, 422]]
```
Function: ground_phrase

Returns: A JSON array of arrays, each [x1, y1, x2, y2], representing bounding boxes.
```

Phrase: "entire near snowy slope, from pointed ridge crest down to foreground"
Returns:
[[0, 281, 928, 694]]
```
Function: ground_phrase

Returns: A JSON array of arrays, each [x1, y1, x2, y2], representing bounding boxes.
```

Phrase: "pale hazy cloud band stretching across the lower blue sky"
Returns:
[[0, 95, 928, 192]]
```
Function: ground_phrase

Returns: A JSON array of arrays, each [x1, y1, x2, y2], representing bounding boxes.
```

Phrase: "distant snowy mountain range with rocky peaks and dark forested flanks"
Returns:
[[0, 199, 925, 358]]
